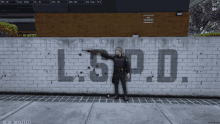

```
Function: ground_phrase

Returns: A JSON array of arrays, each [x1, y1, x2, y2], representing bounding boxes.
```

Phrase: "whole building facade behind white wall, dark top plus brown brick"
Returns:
[[0, 0, 189, 37]]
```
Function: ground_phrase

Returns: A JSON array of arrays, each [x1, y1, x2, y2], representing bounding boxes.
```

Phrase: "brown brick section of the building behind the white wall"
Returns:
[[35, 12, 190, 37]]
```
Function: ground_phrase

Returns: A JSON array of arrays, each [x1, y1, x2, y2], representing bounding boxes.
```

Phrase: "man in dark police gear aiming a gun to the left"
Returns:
[[85, 47, 130, 101]]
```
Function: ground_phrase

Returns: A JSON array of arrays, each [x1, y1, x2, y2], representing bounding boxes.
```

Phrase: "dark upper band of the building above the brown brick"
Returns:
[[0, 0, 189, 13]]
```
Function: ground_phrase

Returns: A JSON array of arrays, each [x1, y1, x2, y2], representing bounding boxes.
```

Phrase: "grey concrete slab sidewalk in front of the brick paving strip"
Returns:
[[0, 101, 220, 124]]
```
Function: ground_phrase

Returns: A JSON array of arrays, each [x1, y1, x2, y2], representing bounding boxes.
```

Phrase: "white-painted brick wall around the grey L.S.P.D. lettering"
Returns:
[[0, 37, 220, 96]]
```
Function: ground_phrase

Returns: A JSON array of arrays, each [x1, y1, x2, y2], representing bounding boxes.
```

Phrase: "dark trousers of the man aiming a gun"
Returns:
[[113, 73, 127, 96]]
